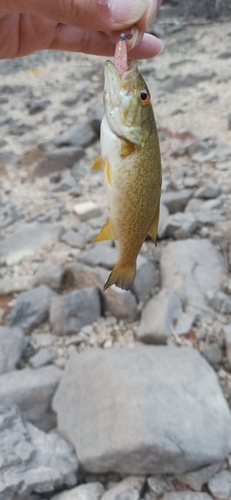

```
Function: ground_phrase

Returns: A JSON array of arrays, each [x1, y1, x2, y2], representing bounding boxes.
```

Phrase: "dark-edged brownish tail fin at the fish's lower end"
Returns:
[[104, 261, 136, 290]]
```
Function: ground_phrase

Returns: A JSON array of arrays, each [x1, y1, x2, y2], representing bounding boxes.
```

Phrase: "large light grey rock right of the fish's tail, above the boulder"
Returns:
[[160, 239, 225, 317]]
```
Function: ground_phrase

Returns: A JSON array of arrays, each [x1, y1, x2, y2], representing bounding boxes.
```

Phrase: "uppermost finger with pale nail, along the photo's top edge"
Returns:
[[0, 0, 158, 33]]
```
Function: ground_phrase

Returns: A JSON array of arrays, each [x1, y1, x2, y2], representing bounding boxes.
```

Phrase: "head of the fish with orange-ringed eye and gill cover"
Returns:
[[104, 59, 154, 145]]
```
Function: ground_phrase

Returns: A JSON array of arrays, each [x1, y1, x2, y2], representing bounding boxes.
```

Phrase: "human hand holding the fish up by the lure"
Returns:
[[0, 0, 162, 59]]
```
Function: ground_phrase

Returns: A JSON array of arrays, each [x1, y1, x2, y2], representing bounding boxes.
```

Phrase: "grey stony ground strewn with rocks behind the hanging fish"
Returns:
[[0, 6, 231, 500]]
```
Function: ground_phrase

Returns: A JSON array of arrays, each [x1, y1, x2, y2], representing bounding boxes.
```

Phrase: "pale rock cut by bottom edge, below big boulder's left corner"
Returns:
[[51, 482, 104, 500]]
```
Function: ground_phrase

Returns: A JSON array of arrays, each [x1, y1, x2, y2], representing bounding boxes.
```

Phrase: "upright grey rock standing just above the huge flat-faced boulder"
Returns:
[[137, 288, 182, 344]]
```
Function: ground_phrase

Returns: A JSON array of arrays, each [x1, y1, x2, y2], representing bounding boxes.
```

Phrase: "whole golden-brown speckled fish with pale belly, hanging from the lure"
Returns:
[[92, 41, 161, 290]]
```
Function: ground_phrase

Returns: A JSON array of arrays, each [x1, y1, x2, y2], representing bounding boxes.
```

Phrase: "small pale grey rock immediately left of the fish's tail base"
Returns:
[[78, 242, 117, 269]]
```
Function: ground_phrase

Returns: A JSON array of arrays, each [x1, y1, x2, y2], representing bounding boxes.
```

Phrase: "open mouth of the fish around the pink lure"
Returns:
[[104, 59, 138, 95]]
